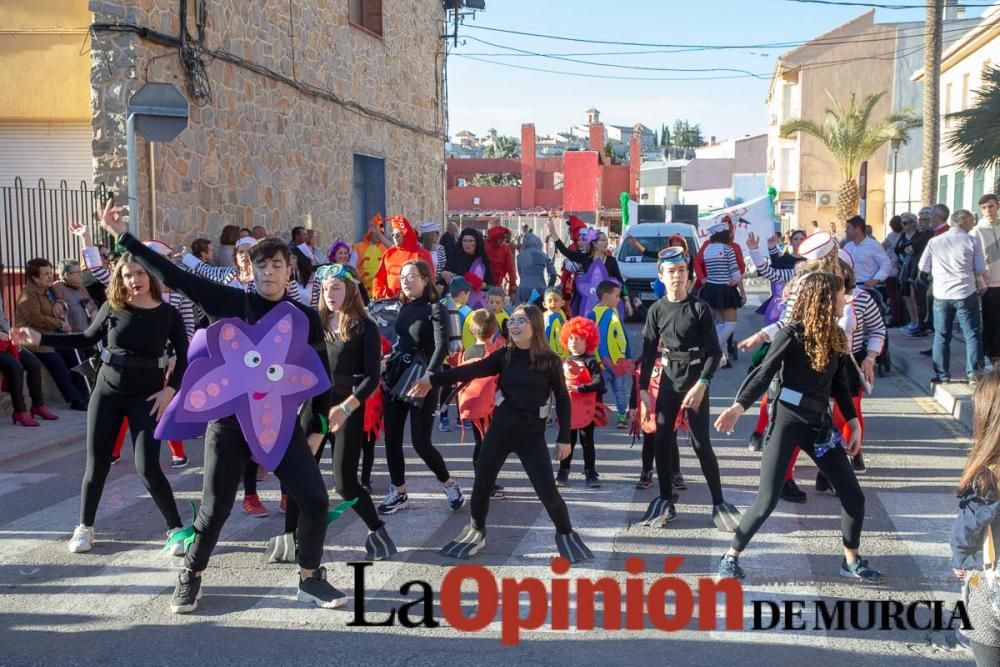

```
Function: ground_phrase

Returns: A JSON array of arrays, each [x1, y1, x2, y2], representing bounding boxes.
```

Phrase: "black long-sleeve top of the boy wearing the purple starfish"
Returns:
[[118, 232, 331, 433]]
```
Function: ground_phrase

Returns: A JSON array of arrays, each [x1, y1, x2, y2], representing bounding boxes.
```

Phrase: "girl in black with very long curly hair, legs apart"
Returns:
[[715, 273, 884, 583]]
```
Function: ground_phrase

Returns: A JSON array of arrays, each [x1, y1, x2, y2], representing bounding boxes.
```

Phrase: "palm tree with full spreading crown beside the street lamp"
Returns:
[[781, 91, 919, 221]]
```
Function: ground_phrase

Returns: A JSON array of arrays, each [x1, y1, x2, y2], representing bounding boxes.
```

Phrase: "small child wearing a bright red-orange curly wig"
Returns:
[[556, 317, 607, 488]]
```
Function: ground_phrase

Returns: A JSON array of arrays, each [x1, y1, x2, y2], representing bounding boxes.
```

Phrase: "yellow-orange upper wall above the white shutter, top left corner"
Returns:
[[0, 0, 91, 121]]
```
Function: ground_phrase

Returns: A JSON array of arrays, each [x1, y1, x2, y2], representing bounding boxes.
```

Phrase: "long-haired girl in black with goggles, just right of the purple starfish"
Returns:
[[267, 264, 397, 562]]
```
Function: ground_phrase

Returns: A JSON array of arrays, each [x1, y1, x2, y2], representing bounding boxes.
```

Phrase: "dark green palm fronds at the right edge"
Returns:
[[947, 67, 1000, 192]]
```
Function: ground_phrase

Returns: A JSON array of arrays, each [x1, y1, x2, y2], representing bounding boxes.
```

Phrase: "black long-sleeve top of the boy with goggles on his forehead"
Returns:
[[639, 294, 722, 393]]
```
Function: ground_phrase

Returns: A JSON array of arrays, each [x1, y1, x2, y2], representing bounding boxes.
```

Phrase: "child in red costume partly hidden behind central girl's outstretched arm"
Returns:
[[458, 309, 507, 499]]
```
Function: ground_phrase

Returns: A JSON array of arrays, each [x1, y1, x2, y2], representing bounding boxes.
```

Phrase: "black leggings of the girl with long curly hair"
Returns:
[[732, 401, 865, 551]]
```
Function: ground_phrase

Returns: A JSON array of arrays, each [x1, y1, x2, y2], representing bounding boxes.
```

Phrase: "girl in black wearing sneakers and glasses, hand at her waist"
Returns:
[[378, 259, 465, 514]]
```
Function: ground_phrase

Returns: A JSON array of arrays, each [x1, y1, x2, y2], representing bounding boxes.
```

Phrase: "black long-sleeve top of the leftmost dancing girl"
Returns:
[[41, 302, 188, 391]]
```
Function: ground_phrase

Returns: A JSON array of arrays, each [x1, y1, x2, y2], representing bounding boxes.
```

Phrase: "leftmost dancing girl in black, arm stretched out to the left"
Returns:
[[17, 254, 188, 556]]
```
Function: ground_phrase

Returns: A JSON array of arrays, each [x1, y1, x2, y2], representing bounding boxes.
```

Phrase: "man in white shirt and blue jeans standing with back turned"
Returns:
[[918, 209, 986, 384]]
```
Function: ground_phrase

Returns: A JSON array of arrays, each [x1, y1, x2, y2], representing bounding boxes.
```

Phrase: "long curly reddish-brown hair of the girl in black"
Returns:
[[789, 273, 848, 372]]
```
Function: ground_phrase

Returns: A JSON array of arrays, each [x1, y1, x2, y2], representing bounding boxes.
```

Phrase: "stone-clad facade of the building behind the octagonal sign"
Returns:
[[90, 0, 445, 247]]
